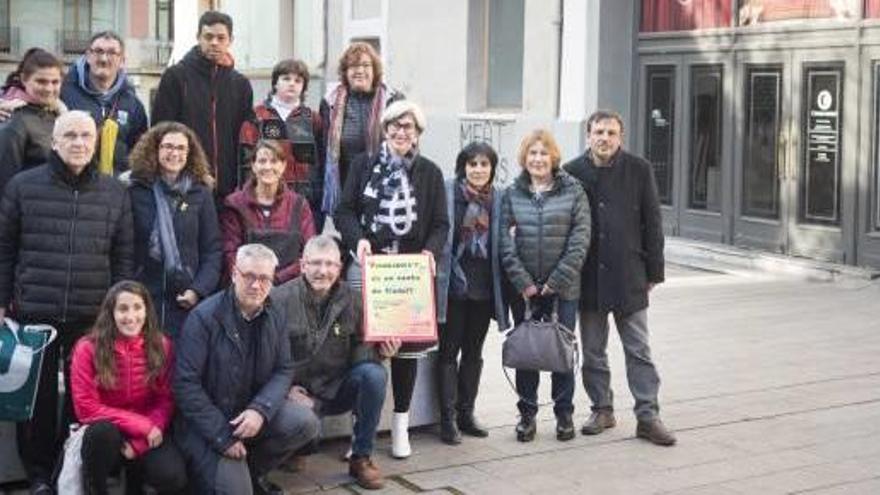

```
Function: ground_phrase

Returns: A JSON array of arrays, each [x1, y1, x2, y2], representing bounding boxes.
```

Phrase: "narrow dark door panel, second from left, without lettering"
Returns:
[[688, 66, 723, 211]]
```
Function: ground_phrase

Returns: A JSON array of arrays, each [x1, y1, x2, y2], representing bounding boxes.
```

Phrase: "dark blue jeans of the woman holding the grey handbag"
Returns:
[[510, 296, 578, 416]]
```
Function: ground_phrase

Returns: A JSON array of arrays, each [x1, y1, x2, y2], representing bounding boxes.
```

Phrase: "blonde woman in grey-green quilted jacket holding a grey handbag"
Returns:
[[501, 129, 590, 442]]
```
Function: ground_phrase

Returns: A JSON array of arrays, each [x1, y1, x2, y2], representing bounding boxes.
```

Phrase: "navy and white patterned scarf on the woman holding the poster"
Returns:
[[364, 142, 418, 251]]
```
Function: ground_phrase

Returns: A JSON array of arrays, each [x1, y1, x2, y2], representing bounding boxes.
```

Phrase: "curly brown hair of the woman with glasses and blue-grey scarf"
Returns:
[[128, 122, 214, 188]]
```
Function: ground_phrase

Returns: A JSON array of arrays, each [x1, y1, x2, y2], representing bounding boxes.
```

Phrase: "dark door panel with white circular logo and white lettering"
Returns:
[[799, 67, 843, 225]]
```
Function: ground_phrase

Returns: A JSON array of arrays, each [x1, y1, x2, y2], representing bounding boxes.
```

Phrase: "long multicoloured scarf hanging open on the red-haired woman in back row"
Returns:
[[321, 84, 385, 216]]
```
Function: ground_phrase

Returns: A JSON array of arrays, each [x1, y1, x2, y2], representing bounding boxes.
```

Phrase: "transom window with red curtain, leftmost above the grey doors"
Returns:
[[641, 0, 733, 33]]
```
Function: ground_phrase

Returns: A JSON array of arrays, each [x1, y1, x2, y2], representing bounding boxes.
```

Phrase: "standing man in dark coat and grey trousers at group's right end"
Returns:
[[564, 111, 675, 445]]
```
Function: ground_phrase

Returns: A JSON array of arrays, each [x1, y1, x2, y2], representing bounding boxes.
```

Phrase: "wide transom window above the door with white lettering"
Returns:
[[737, 0, 856, 26]]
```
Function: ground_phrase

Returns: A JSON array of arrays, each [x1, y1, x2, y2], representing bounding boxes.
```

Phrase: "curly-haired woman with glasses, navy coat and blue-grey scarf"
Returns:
[[128, 122, 223, 336]]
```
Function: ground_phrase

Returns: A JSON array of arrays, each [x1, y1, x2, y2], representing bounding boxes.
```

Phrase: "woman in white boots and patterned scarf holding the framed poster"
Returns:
[[333, 100, 449, 458]]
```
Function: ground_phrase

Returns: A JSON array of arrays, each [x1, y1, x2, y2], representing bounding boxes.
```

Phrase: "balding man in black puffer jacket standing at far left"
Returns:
[[0, 110, 134, 493]]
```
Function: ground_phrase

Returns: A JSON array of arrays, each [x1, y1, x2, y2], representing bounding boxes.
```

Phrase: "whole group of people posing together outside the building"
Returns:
[[0, 6, 675, 494]]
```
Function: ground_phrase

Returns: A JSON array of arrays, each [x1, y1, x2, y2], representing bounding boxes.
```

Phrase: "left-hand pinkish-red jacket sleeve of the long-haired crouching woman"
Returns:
[[70, 337, 154, 440]]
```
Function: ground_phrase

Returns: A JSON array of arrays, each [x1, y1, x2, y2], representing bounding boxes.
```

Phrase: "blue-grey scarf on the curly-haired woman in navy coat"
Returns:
[[149, 173, 193, 275]]
